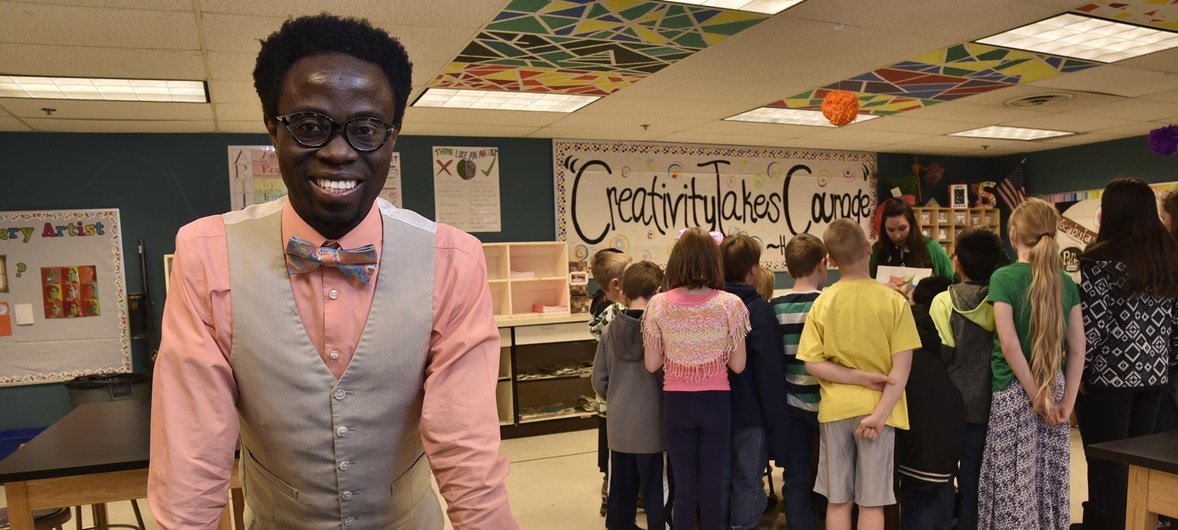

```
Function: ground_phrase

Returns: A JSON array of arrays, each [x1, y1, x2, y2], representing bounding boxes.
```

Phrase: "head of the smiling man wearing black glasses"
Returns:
[[253, 14, 412, 239]]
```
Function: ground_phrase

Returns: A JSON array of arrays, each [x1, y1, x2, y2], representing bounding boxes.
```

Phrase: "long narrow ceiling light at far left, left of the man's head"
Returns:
[[0, 75, 209, 102]]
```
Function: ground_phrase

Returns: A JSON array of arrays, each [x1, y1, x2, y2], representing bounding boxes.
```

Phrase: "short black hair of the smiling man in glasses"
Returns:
[[253, 13, 413, 128]]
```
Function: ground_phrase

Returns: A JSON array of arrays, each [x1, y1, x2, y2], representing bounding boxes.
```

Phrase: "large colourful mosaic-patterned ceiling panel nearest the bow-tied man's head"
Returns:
[[430, 0, 768, 95]]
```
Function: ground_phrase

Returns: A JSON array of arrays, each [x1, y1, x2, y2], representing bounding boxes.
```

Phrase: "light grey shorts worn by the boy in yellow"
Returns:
[[814, 416, 895, 506]]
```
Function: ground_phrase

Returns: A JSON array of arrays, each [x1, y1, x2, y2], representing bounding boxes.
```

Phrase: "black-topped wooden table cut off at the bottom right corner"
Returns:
[[1087, 431, 1178, 530]]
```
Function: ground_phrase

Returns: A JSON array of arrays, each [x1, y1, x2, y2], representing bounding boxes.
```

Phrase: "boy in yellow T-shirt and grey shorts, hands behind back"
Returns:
[[798, 219, 920, 530]]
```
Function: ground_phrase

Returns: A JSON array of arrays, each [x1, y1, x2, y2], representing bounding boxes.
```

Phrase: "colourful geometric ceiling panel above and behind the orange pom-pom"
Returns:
[[769, 42, 1099, 115]]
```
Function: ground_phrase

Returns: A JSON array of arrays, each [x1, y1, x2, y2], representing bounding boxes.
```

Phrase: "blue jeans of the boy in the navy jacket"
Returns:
[[721, 428, 769, 530]]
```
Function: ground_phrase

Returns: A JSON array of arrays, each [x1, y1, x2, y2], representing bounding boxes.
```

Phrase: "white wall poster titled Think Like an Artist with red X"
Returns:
[[434, 146, 502, 232]]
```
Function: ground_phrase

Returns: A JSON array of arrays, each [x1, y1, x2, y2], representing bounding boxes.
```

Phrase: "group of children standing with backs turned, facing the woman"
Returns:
[[593, 199, 1084, 530]]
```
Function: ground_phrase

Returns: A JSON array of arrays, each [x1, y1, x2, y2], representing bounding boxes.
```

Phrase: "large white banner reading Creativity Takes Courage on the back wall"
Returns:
[[552, 140, 876, 271]]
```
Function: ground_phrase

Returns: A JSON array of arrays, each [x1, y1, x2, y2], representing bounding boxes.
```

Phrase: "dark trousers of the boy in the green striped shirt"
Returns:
[[777, 410, 818, 530]]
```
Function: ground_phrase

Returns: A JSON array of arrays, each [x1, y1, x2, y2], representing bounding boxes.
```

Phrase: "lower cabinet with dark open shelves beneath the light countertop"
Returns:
[[496, 314, 597, 438]]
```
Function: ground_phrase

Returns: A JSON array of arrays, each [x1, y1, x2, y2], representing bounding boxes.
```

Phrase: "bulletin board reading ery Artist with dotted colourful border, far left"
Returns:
[[0, 208, 131, 386]]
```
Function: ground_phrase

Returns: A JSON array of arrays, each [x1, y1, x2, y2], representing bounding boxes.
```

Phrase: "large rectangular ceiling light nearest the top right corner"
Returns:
[[978, 13, 1178, 62]]
